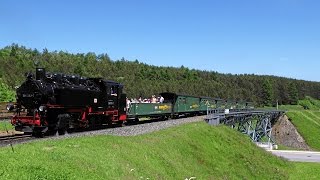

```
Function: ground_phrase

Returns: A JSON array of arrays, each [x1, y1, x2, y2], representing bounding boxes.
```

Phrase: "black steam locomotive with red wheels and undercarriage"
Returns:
[[11, 68, 127, 135]]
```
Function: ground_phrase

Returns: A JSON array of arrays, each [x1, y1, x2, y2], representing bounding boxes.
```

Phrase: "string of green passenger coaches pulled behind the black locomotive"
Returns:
[[127, 92, 253, 121]]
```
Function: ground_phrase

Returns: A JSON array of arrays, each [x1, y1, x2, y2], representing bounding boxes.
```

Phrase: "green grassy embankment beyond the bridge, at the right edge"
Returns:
[[280, 97, 320, 151]]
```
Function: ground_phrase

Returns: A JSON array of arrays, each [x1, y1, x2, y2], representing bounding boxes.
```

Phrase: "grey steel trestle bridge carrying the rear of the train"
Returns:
[[205, 109, 285, 144]]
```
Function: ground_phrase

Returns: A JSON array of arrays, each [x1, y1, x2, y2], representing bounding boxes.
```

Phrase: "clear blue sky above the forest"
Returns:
[[0, 0, 320, 81]]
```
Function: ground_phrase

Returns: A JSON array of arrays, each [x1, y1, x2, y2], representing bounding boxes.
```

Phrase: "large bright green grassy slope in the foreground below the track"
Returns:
[[0, 123, 293, 179]]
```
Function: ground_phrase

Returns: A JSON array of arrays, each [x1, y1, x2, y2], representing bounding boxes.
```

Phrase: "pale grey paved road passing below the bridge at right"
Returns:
[[269, 150, 320, 163]]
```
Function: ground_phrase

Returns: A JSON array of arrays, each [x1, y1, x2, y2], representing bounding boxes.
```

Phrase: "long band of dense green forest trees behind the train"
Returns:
[[0, 44, 320, 106]]
